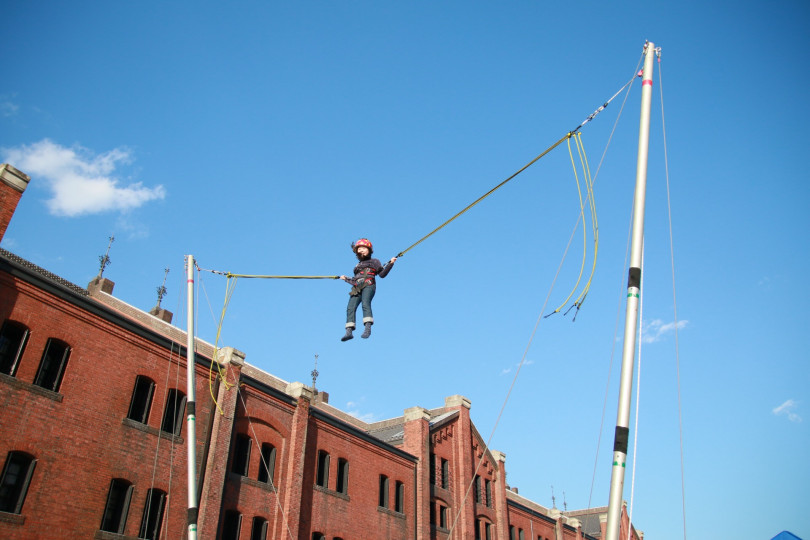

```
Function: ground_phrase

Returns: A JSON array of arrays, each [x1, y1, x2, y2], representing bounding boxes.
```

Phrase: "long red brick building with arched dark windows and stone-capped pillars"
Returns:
[[0, 161, 643, 540]]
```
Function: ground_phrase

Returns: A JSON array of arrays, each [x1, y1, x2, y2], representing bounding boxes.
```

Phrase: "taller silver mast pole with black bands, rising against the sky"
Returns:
[[605, 41, 655, 540]]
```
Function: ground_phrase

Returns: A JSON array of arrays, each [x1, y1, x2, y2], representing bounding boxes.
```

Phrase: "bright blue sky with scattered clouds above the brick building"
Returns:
[[0, 0, 810, 539]]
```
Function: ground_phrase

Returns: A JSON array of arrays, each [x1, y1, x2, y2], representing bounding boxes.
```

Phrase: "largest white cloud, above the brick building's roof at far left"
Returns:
[[2, 139, 166, 217]]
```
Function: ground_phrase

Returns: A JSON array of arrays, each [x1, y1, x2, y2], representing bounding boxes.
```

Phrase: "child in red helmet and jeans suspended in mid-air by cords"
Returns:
[[340, 238, 397, 341]]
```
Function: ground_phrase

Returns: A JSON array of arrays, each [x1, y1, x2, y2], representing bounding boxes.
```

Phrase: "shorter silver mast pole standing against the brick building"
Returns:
[[186, 255, 198, 540]]
